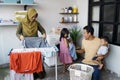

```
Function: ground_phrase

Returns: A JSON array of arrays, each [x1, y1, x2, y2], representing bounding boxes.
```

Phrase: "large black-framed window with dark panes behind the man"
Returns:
[[88, 0, 120, 46]]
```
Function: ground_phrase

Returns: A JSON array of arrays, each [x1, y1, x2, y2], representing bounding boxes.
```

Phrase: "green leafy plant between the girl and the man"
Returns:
[[70, 26, 81, 46]]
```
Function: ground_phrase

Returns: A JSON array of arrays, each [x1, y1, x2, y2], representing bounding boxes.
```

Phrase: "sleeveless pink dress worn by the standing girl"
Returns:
[[59, 38, 72, 64]]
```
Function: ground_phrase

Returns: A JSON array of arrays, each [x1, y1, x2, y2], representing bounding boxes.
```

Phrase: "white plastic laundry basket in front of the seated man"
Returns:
[[69, 63, 94, 80]]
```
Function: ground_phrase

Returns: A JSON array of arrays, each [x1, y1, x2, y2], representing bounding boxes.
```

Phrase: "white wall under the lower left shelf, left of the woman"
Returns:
[[0, 26, 20, 64]]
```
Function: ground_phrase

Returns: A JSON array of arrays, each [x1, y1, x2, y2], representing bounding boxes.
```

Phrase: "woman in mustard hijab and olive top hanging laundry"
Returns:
[[16, 8, 46, 79]]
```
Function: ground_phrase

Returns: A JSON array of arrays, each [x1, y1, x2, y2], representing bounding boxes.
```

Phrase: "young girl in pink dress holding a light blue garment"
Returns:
[[59, 28, 77, 72]]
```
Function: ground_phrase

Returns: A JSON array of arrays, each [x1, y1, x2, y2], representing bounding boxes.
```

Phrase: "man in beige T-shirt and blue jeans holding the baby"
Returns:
[[76, 26, 100, 80]]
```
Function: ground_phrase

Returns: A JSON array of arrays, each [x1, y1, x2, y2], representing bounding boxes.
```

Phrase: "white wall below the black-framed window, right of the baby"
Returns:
[[106, 45, 120, 77]]
